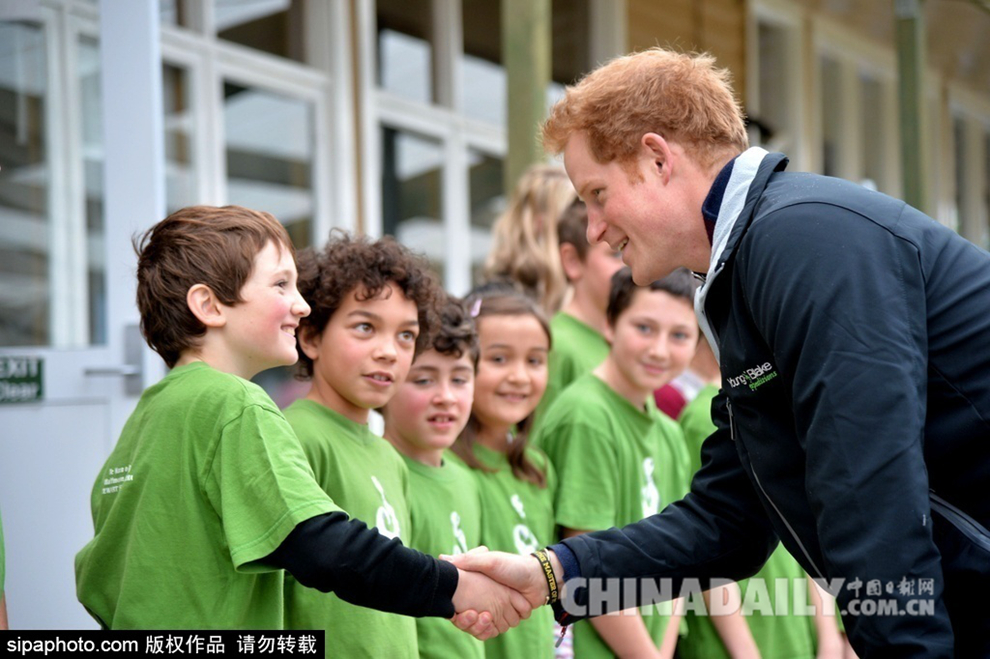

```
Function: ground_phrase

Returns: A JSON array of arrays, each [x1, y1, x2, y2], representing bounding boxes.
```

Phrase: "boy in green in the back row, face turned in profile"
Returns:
[[537, 200, 622, 418]]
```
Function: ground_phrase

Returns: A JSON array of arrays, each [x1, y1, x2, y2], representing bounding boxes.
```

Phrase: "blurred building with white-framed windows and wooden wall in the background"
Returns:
[[0, 0, 990, 629]]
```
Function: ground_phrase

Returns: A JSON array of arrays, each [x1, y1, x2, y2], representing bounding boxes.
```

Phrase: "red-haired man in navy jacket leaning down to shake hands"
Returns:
[[459, 48, 990, 657]]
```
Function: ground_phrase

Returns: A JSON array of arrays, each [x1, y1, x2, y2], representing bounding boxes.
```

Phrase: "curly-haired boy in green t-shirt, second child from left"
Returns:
[[285, 232, 442, 658]]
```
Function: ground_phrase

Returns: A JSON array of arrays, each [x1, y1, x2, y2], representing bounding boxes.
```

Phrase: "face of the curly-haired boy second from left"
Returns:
[[300, 283, 419, 423]]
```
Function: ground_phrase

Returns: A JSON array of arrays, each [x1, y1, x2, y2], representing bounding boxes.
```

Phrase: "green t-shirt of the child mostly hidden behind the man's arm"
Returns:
[[678, 385, 817, 659]]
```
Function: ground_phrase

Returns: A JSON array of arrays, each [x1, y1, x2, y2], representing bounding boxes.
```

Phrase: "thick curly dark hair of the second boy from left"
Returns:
[[297, 229, 443, 379]]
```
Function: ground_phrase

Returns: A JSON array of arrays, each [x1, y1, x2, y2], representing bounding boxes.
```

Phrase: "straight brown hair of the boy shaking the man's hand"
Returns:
[[132, 206, 295, 368]]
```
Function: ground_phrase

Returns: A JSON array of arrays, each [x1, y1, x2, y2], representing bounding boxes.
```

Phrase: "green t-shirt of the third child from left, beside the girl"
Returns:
[[402, 456, 485, 659]]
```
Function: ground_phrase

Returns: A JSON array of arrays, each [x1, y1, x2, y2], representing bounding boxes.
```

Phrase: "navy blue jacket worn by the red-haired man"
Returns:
[[564, 154, 990, 658]]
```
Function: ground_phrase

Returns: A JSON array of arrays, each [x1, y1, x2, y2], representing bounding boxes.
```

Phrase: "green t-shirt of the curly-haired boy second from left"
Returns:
[[285, 399, 417, 659]]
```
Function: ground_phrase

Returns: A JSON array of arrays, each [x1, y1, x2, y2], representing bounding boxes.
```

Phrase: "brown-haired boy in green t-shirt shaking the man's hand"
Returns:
[[76, 206, 528, 636]]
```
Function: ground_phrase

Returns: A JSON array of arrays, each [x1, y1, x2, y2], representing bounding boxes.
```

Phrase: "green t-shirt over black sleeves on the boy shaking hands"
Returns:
[[75, 362, 339, 629]]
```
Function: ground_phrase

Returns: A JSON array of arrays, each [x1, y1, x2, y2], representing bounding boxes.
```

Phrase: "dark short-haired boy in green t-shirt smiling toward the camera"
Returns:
[[536, 268, 698, 659]]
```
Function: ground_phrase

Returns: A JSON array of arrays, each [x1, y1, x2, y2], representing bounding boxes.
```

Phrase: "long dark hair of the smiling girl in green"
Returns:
[[451, 282, 551, 487]]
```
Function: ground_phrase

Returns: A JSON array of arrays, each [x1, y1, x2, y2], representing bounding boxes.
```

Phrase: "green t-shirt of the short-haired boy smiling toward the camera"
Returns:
[[534, 373, 689, 659]]
